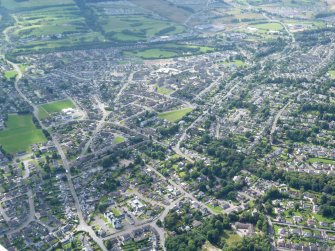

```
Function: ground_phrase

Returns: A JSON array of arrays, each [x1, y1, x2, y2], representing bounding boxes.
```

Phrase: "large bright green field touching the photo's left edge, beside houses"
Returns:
[[0, 115, 46, 153]]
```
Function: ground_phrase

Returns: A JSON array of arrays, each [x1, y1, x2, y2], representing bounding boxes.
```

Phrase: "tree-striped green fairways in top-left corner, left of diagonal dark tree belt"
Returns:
[[2, 0, 106, 54]]
